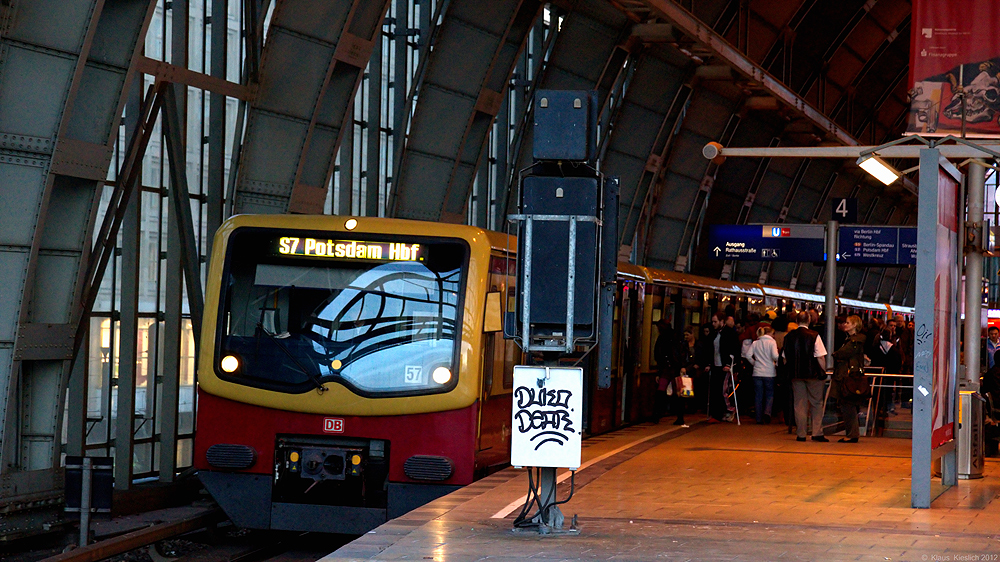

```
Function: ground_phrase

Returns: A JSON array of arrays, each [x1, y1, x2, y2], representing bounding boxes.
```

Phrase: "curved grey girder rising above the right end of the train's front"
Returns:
[[389, 0, 542, 222]]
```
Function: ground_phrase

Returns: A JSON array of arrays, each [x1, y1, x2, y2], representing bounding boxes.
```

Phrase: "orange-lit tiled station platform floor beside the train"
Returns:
[[321, 416, 1000, 562]]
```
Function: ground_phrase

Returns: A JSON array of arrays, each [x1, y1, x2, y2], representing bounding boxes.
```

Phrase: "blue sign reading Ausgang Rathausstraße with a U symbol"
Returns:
[[708, 224, 826, 262]]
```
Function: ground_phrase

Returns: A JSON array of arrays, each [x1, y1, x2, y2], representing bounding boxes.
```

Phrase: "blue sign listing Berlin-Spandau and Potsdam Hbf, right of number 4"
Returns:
[[837, 226, 917, 265]]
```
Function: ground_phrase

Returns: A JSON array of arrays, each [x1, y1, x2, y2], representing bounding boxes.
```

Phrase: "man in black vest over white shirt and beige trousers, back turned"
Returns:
[[782, 312, 829, 442]]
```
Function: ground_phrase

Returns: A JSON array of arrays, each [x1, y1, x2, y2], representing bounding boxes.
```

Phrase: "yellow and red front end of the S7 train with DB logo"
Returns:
[[195, 215, 490, 534]]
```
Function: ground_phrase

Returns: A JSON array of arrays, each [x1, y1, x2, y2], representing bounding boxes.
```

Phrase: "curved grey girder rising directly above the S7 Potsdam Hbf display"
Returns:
[[234, 0, 389, 213]]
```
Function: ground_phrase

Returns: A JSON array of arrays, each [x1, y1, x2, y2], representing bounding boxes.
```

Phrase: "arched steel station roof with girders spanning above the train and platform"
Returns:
[[0, 0, 932, 536]]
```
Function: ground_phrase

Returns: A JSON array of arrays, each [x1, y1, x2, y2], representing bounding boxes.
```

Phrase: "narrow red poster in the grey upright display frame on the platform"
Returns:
[[931, 169, 961, 449]]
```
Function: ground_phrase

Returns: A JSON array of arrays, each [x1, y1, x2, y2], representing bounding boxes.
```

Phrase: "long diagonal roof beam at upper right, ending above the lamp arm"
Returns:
[[645, 0, 859, 146]]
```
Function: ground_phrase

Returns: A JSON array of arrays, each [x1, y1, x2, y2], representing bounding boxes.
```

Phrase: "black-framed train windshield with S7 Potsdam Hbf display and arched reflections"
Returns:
[[216, 229, 468, 396]]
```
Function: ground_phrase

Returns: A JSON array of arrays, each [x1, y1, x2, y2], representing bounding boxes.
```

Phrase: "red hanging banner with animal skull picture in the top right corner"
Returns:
[[906, 0, 1000, 137]]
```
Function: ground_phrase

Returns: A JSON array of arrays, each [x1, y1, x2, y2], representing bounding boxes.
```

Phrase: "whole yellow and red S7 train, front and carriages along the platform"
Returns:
[[195, 215, 912, 534]]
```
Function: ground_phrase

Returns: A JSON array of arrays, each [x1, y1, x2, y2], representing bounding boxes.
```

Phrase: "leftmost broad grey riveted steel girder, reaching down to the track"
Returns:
[[0, 0, 155, 533]]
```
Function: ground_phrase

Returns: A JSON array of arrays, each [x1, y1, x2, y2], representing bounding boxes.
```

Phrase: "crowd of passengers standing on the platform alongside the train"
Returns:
[[653, 307, 916, 443]]
